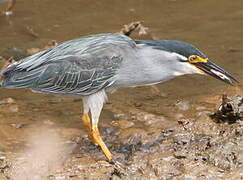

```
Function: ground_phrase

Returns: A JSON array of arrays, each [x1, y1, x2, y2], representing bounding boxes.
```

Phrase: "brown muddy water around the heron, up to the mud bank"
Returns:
[[0, 0, 243, 179]]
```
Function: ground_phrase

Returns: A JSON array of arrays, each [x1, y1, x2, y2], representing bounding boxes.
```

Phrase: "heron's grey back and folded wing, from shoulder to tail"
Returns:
[[1, 34, 136, 96]]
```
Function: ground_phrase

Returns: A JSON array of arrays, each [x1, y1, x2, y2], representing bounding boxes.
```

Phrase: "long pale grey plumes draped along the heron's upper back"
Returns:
[[9, 34, 136, 71]]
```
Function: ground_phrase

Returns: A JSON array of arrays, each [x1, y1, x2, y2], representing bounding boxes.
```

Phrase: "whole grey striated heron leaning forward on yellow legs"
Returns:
[[1, 34, 237, 161]]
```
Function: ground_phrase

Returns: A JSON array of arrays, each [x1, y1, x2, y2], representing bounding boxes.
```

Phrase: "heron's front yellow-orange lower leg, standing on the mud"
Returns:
[[91, 125, 112, 162]]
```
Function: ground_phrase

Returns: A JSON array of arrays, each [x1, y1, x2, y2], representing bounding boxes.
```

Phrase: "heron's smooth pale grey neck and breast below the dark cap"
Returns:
[[114, 47, 197, 86]]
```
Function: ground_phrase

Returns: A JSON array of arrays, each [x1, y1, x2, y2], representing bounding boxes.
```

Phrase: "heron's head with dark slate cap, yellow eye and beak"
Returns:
[[135, 40, 238, 85]]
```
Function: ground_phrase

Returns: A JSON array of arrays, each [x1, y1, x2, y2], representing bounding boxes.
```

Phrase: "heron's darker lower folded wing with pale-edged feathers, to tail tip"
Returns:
[[0, 55, 122, 96]]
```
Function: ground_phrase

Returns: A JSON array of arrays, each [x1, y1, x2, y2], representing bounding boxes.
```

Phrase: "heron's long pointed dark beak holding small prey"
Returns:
[[194, 60, 239, 85]]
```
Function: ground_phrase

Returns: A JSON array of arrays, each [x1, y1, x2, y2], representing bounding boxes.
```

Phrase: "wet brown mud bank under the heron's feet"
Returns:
[[0, 93, 243, 179]]
